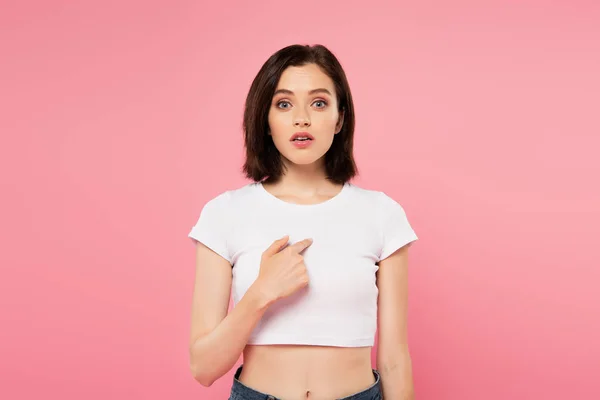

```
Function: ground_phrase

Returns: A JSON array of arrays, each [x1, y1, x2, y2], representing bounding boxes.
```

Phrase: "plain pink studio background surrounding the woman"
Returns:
[[0, 0, 600, 400]]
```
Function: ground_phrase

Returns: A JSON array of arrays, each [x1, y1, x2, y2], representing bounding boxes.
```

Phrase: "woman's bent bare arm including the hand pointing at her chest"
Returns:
[[190, 235, 312, 386]]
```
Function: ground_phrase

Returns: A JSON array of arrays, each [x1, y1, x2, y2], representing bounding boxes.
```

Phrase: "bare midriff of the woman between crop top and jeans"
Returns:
[[238, 345, 375, 400]]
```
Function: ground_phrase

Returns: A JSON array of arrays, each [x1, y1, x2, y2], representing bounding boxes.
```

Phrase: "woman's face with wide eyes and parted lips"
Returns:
[[269, 64, 343, 169]]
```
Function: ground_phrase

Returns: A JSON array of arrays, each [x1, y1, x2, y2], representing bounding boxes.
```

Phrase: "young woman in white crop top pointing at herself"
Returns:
[[189, 45, 417, 400]]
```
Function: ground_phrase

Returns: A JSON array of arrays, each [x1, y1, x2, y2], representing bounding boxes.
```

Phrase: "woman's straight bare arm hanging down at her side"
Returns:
[[377, 244, 415, 400]]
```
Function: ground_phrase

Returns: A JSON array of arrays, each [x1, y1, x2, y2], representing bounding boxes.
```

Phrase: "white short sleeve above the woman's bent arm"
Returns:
[[188, 192, 231, 263]]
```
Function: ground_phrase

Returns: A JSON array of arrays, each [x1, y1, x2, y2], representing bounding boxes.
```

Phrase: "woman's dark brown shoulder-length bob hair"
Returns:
[[243, 44, 358, 183]]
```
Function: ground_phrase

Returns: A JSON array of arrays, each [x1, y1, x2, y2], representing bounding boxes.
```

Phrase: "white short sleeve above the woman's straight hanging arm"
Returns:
[[378, 192, 418, 261]]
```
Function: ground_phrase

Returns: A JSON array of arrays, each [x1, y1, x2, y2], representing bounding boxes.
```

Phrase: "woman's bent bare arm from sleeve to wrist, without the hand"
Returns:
[[190, 242, 271, 386]]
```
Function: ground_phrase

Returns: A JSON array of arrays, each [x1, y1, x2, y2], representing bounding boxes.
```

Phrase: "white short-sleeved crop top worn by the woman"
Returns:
[[188, 182, 417, 347]]
